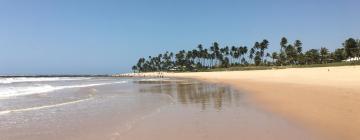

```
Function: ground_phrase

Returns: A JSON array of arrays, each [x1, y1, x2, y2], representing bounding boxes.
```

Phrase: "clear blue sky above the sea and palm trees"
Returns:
[[0, 0, 360, 75]]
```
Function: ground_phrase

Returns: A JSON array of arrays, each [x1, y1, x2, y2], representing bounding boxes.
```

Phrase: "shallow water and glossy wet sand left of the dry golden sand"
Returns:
[[0, 78, 313, 140]]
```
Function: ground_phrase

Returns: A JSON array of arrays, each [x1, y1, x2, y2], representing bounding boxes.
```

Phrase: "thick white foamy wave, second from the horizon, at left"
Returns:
[[0, 81, 127, 99]]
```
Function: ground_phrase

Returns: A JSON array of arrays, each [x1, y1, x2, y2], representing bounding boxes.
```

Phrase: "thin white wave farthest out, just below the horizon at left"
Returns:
[[0, 77, 90, 84]]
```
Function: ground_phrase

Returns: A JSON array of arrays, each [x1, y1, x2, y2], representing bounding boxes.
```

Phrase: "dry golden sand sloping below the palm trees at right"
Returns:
[[134, 66, 360, 140]]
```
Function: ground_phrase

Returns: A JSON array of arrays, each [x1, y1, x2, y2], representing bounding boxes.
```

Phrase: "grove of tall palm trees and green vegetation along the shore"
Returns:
[[132, 37, 360, 72]]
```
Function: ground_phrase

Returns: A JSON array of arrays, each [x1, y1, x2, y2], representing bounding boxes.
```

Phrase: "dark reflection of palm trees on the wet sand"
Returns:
[[137, 80, 241, 111]]
